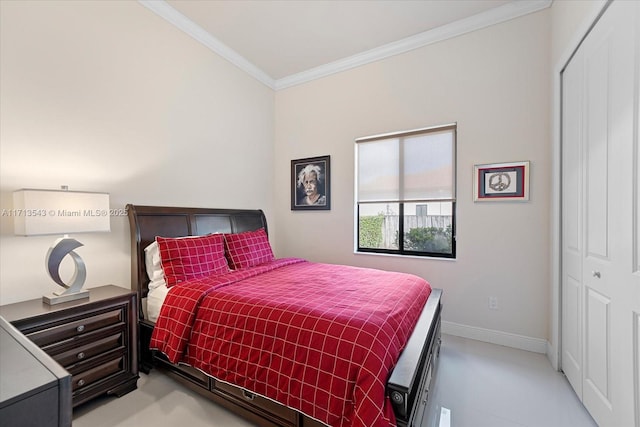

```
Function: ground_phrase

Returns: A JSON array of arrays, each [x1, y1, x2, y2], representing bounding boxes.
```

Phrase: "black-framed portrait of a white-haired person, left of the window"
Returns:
[[291, 156, 331, 211]]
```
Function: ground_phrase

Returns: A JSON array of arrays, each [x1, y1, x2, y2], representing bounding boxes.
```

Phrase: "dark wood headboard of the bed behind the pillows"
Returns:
[[127, 204, 268, 315]]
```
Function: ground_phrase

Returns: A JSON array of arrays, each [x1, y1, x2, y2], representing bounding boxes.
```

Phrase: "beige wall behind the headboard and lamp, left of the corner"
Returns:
[[0, 1, 275, 304]]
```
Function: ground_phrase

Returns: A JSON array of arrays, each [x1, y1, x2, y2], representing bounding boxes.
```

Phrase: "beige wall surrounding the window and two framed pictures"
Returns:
[[274, 9, 551, 342]]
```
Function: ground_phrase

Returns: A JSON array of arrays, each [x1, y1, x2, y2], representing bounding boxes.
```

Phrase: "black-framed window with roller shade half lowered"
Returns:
[[355, 124, 456, 258]]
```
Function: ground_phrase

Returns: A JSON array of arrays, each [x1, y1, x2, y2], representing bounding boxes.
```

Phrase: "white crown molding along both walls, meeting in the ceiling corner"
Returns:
[[138, 0, 553, 90]]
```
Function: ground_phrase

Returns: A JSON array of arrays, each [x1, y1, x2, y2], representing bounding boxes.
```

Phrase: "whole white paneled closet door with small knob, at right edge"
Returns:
[[562, 1, 640, 427]]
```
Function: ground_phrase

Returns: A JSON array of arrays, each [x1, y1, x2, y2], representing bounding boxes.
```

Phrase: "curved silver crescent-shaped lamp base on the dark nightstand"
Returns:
[[42, 236, 89, 305]]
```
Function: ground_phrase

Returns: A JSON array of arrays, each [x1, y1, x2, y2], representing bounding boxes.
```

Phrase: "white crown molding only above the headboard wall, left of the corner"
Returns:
[[138, 0, 276, 89]]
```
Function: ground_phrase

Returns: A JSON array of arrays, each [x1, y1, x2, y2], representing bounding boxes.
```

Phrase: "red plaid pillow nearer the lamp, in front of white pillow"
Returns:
[[156, 234, 229, 288]]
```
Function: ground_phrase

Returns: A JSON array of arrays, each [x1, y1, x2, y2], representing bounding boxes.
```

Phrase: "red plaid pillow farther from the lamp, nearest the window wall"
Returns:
[[224, 228, 275, 269]]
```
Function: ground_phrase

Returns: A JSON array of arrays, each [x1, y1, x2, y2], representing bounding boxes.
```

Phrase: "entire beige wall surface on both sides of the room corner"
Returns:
[[0, 1, 597, 352]]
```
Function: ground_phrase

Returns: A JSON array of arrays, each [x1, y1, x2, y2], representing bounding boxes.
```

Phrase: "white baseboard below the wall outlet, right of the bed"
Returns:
[[442, 321, 549, 354]]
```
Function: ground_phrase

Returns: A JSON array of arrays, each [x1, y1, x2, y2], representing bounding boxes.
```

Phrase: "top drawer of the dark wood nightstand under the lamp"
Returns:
[[26, 308, 124, 347]]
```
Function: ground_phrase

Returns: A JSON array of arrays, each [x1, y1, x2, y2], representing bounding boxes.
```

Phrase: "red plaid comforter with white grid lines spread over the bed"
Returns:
[[150, 258, 431, 427]]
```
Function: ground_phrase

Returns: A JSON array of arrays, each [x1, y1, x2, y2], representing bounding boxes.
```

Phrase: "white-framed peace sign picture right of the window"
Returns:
[[473, 162, 529, 202]]
